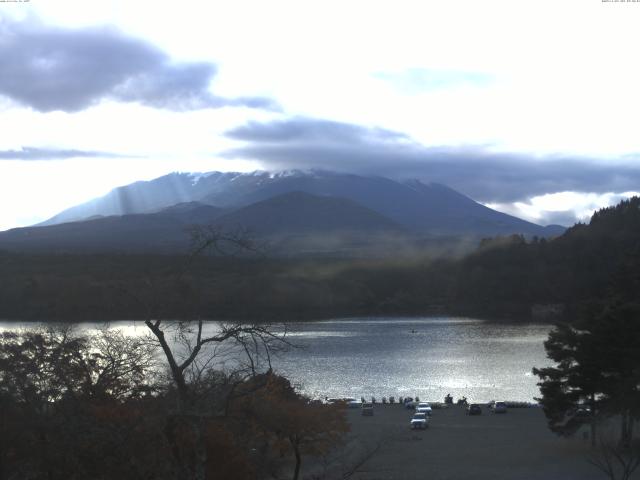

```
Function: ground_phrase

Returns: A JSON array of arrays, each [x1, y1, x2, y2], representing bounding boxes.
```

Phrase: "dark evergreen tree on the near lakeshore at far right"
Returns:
[[533, 302, 640, 445]]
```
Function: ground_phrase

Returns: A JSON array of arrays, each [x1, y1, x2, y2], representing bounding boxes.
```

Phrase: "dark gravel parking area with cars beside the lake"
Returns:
[[338, 404, 616, 480]]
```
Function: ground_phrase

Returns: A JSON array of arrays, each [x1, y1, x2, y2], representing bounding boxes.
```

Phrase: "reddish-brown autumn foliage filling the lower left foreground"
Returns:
[[0, 330, 348, 480]]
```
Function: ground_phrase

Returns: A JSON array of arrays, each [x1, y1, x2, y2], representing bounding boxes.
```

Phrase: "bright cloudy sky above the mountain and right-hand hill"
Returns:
[[0, 0, 640, 230]]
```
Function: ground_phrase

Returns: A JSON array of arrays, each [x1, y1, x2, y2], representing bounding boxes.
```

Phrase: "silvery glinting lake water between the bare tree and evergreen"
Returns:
[[0, 317, 551, 402]]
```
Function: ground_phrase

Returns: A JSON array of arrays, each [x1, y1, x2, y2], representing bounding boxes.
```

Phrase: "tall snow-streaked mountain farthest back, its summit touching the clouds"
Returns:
[[41, 170, 564, 236]]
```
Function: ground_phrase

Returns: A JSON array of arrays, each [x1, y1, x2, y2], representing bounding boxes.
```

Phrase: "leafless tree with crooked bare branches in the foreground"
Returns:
[[144, 227, 288, 480]]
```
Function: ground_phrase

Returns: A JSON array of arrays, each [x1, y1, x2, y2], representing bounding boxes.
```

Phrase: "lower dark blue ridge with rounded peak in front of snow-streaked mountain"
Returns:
[[0, 192, 405, 254]]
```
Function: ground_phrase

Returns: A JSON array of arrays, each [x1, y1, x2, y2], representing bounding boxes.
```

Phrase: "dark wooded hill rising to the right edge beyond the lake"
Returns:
[[452, 197, 640, 318]]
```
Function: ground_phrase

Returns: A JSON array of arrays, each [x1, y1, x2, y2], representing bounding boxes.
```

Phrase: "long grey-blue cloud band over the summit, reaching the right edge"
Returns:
[[226, 118, 640, 202]]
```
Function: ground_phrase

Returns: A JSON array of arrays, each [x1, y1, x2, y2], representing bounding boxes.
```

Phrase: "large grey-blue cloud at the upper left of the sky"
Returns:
[[0, 22, 277, 112]]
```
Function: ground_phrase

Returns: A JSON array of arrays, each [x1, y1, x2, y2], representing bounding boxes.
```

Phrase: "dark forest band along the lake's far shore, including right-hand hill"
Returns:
[[0, 198, 640, 322]]
